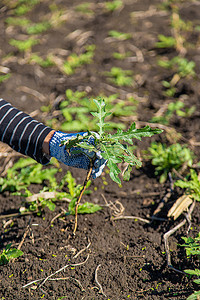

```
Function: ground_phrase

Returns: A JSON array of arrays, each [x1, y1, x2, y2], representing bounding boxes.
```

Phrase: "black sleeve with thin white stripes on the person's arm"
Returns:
[[0, 99, 52, 164]]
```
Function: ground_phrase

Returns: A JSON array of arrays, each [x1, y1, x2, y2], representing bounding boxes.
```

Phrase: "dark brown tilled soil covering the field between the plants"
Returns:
[[0, 0, 200, 300]]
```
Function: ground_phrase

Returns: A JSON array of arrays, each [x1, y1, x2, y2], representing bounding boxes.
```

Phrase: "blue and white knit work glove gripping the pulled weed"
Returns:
[[49, 131, 106, 179]]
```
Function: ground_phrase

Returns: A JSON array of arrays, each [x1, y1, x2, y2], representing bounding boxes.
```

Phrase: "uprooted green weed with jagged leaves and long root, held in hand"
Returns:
[[61, 99, 162, 234]]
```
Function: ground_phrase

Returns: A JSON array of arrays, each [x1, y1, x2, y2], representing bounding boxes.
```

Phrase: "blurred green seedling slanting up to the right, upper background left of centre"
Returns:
[[62, 45, 95, 75]]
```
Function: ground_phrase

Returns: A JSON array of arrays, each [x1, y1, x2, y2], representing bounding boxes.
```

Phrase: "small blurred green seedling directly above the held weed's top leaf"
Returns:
[[104, 67, 133, 86]]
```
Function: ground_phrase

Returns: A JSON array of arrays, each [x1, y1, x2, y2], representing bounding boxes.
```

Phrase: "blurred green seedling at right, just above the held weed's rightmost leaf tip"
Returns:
[[151, 100, 195, 125]]
